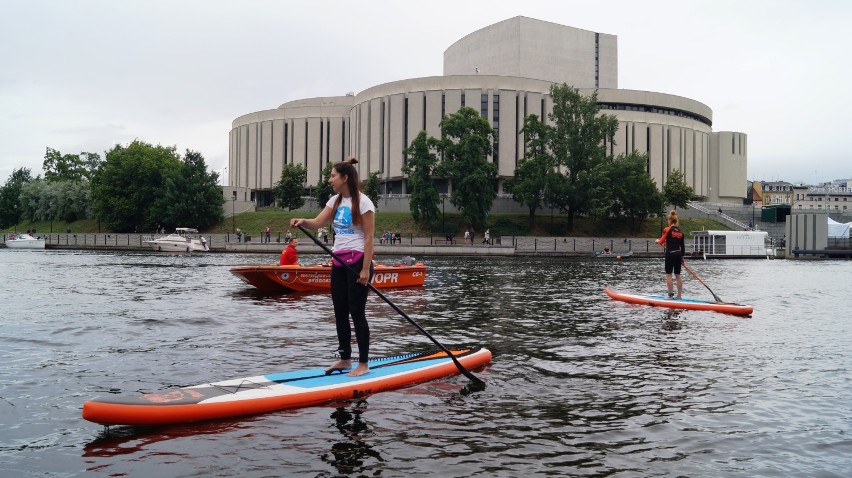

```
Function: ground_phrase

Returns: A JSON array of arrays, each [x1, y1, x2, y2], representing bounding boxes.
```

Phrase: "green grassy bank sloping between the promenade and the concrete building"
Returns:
[[3, 208, 730, 237]]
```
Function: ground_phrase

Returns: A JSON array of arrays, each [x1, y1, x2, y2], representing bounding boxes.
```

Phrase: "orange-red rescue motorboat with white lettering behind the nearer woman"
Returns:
[[231, 262, 426, 292]]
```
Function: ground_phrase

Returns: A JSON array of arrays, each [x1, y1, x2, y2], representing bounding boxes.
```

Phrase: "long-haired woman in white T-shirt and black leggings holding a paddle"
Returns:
[[290, 158, 376, 377]]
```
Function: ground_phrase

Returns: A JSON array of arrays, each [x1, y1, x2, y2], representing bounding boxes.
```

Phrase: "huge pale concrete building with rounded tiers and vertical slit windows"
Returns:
[[228, 17, 748, 206]]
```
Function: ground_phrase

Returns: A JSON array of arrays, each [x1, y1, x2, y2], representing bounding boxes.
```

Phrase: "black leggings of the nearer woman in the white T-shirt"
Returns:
[[331, 258, 373, 363]]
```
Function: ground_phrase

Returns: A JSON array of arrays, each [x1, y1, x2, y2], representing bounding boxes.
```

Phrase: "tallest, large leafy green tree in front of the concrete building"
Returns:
[[545, 84, 618, 231]]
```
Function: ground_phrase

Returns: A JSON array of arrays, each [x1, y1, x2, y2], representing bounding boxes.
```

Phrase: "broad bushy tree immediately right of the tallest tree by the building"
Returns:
[[609, 151, 664, 234]]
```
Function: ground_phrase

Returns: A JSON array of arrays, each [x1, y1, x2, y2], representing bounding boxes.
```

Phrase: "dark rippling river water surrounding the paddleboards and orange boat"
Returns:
[[0, 250, 852, 477]]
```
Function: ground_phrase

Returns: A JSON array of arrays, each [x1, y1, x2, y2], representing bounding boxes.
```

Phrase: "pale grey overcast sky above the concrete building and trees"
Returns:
[[0, 0, 852, 184]]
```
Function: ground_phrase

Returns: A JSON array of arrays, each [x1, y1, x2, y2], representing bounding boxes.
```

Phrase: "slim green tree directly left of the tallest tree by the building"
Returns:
[[507, 115, 554, 229]]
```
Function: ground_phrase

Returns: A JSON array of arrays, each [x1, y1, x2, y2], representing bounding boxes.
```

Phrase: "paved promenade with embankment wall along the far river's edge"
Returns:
[[0, 233, 662, 257]]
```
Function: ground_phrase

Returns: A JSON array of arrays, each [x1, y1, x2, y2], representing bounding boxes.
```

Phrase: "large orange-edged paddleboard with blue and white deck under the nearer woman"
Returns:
[[83, 347, 491, 425]]
